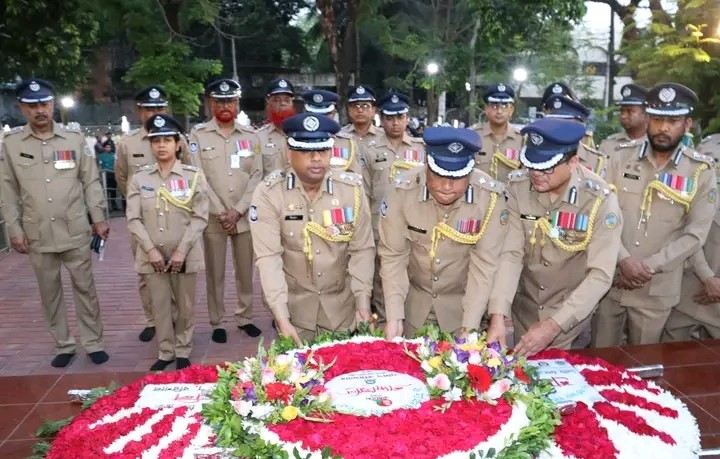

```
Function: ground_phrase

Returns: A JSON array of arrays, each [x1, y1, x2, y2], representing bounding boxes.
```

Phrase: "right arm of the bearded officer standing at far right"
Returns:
[[643, 165, 717, 274]]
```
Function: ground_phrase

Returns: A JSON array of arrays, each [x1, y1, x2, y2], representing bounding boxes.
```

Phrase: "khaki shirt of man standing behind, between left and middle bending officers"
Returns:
[[362, 133, 425, 234]]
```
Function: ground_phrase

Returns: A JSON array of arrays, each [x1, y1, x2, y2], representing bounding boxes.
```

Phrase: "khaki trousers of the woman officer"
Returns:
[[144, 273, 197, 360]]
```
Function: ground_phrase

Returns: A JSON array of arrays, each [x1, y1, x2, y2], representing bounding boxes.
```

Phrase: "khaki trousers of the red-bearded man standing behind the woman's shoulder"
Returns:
[[203, 226, 253, 329]]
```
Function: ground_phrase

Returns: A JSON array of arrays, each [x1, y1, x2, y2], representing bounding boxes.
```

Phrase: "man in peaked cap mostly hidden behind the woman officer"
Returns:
[[115, 85, 168, 342]]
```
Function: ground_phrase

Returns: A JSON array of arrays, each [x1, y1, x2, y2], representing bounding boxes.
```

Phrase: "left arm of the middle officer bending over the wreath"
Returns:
[[378, 189, 410, 322]]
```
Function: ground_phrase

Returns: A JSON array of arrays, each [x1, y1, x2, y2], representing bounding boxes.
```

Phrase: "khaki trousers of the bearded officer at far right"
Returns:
[[591, 294, 672, 347]]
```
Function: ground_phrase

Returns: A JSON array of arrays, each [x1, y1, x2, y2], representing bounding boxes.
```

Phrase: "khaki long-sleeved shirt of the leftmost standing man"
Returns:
[[0, 123, 107, 252]]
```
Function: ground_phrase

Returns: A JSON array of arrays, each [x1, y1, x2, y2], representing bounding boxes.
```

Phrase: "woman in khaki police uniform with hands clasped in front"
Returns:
[[127, 114, 209, 371]]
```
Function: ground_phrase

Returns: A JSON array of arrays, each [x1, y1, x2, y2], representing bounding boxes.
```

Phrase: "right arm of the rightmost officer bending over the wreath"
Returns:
[[552, 194, 623, 332]]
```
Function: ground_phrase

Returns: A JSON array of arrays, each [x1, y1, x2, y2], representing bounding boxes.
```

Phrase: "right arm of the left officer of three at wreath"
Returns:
[[348, 190, 375, 311]]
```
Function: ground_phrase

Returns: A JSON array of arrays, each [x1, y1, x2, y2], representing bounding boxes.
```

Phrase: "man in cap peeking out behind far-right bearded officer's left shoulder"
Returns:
[[598, 83, 648, 157]]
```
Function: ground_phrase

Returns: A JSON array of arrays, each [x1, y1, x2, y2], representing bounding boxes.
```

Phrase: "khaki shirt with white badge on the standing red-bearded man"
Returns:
[[190, 119, 263, 233]]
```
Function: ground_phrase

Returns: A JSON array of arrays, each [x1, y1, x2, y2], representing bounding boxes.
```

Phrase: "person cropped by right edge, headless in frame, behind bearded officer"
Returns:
[[662, 138, 720, 341]]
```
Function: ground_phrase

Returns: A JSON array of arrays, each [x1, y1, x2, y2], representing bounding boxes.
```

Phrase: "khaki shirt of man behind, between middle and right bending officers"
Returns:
[[470, 123, 523, 182]]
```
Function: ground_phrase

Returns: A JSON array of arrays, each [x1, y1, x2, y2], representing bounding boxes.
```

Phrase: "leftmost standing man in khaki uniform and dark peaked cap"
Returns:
[[0, 78, 110, 367]]
